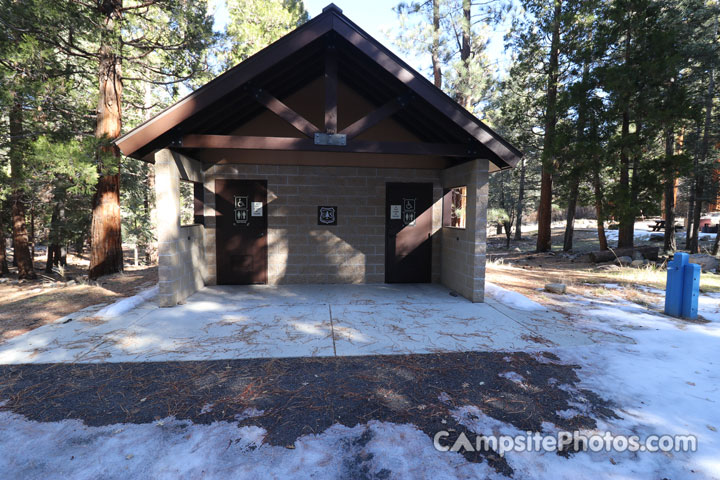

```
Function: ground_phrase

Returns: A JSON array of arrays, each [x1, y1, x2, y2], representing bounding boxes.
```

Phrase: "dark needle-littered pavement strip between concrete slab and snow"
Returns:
[[0, 352, 615, 475]]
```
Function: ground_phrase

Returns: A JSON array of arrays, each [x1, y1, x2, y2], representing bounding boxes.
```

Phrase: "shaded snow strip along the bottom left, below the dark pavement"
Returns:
[[0, 412, 500, 480]]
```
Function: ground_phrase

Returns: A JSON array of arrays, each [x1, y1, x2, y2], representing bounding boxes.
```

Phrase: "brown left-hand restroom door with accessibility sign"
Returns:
[[215, 180, 267, 285]]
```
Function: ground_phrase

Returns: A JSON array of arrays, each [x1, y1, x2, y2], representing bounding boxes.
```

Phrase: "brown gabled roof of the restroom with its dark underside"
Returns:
[[115, 4, 522, 169]]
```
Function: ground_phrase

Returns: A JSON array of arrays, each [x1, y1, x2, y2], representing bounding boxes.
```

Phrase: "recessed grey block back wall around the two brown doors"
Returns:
[[205, 164, 442, 285]]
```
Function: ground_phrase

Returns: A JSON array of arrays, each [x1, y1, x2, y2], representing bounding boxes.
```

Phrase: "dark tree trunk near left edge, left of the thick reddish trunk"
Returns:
[[9, 93, 37, 280]]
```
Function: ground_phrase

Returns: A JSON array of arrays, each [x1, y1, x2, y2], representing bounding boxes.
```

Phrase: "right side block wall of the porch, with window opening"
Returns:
[[441, 160, 489, 302]]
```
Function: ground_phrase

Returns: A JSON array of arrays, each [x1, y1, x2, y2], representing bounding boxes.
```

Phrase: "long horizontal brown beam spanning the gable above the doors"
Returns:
[[179, 135, 481, 158]]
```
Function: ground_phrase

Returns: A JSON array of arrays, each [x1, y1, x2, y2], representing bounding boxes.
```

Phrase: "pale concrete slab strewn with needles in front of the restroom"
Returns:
[[0, 284, 622, 364]]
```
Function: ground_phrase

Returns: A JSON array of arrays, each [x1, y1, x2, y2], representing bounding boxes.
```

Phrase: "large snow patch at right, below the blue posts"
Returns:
[[490, 295, 720, 479]]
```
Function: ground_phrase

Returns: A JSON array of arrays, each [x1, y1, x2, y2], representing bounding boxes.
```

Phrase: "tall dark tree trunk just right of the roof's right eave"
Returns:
[[537, 0, 562, 252]]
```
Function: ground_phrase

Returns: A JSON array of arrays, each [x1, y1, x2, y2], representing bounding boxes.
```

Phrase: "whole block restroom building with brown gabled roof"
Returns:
[[115, 5, 522, 306]]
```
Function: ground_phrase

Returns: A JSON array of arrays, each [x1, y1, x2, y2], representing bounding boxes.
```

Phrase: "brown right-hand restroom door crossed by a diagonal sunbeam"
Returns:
[[385, 183, 433, 283]]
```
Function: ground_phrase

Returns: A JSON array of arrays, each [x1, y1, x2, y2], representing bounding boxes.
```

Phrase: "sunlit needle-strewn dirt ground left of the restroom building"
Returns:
[[0, 251, 157, 343]]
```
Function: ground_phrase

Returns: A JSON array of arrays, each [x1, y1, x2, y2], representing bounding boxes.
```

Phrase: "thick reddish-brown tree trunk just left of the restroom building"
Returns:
[[89, 7, 123, 279]]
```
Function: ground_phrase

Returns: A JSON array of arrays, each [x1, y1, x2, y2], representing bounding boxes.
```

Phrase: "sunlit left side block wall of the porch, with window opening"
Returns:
[[155, 149, 207, 307]]
